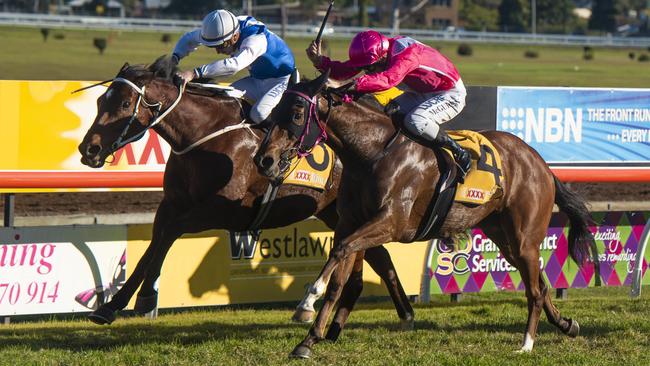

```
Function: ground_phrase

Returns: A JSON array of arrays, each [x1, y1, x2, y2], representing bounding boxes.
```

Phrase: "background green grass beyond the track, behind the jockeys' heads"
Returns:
[[0, 27, 650, 88]]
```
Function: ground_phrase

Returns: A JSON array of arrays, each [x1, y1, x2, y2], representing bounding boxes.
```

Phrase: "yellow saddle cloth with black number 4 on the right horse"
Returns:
[[447, 130, 503, 205]]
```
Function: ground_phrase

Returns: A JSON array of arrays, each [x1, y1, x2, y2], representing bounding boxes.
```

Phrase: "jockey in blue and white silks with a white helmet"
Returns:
[[172, 10, 296, 123]]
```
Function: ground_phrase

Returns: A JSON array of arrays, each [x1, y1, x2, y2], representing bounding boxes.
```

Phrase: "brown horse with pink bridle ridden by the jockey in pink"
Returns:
[[255, 73, 593, 358]]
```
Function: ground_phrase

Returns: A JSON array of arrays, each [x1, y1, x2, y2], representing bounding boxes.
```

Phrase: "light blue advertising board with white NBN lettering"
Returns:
[[496, 87, 650, 167]]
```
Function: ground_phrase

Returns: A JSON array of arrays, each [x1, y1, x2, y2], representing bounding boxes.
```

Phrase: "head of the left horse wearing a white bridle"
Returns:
[[79, 56, 180, 168]]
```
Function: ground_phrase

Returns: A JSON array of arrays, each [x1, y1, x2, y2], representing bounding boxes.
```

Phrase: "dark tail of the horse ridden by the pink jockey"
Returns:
[[553, 176, 596, 264]]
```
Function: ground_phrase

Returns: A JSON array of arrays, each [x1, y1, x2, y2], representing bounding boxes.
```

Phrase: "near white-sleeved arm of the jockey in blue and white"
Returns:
[[194, 34, 268, 78]]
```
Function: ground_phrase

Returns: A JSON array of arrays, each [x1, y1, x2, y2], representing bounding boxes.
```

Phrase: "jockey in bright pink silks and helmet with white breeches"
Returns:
[[307, 30, 471, 177]]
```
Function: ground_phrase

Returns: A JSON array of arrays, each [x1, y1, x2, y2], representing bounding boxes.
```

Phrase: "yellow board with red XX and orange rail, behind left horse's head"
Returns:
[[0, 80, 170, 192]]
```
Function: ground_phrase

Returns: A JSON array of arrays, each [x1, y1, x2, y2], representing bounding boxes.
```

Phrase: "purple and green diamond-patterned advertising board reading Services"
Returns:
[[425, 211, 650, 294]]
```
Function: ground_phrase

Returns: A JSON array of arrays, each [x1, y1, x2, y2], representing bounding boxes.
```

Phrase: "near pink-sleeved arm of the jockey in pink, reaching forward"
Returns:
[[355, 45, 420, 93]]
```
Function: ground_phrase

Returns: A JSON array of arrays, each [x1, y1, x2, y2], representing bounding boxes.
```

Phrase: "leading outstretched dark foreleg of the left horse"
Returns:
[[88, 200, 173, 324]]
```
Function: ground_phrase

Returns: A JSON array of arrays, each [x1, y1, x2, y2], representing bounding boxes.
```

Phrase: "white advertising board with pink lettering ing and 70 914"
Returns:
[[0, 226, 126, 316]]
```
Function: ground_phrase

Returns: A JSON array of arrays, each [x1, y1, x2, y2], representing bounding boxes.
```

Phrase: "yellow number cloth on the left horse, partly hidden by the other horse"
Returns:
[[283, 142, 336, 190]]
